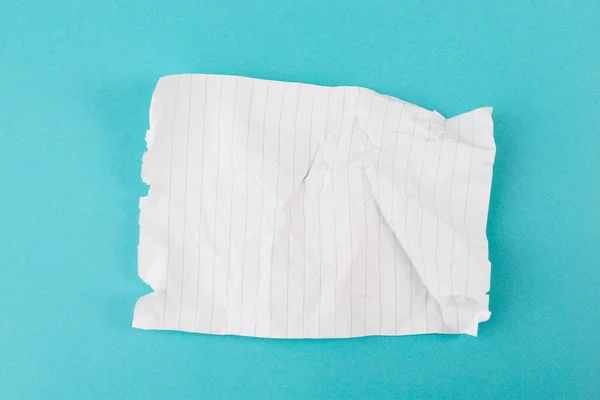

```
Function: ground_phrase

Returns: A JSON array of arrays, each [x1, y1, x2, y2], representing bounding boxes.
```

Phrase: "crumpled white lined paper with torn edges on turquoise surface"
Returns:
[[133, 75, 495, 338]]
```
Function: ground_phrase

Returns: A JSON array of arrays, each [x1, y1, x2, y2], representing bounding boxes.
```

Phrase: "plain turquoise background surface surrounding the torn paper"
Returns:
[[0, 0, 600, 400]]
